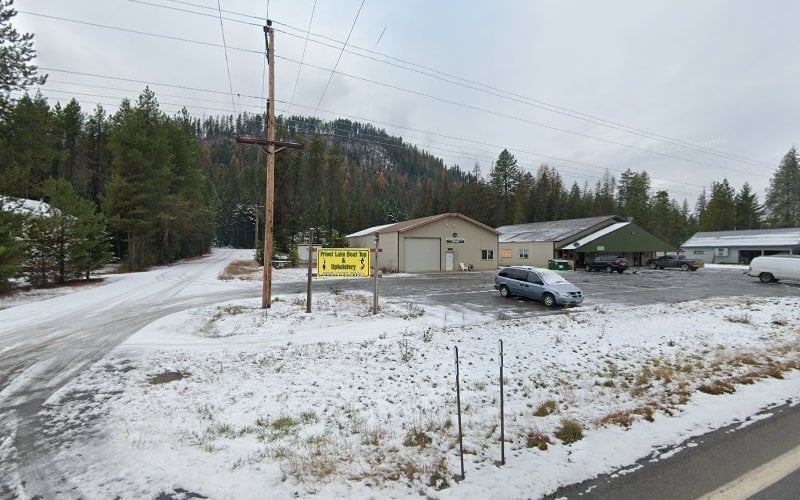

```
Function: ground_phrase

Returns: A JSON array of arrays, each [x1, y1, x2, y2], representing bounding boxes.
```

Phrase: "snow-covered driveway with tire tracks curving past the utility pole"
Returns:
[[0, 250, 261, 499]]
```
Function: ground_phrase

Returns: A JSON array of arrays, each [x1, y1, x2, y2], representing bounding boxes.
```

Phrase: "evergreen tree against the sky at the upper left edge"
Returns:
[[0, 0, 47, 123]]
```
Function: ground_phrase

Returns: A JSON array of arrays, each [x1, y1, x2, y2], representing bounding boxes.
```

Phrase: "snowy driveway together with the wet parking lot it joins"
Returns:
[[0, 258, 800, 498]]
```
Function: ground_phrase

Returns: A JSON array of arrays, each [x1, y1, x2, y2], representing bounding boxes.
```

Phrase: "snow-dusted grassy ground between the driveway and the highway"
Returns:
[[1, 256, 800, 499]]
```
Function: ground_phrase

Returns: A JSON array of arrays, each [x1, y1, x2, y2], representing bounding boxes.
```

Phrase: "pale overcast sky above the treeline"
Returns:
[[14, 0, 800, 207]]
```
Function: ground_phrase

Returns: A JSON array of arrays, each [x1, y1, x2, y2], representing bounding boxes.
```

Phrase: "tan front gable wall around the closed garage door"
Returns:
[[398, 217, 497, 271]]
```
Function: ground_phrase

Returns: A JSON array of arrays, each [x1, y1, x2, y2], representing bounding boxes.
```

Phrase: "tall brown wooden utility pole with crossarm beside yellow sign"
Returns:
[[236, 19, 303, 309]]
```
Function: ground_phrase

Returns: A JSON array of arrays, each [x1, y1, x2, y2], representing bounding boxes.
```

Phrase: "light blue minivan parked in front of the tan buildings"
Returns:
[[494, 266, 583, 307]]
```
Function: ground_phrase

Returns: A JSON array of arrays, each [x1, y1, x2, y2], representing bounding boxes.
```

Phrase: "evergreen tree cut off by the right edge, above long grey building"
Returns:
[[766, 147, 800, 228]]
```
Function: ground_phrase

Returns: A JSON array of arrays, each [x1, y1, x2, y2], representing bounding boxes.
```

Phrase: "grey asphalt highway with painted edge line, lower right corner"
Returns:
[[547, 405, 800, 500]]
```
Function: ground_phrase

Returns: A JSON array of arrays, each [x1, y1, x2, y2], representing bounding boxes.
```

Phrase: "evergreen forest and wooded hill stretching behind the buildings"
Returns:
[[0, 85, 800, 292]]
